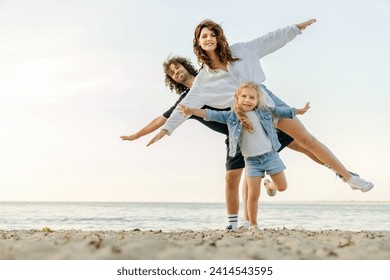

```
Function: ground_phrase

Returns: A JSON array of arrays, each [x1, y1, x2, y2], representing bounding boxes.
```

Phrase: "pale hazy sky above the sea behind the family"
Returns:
[[0, 0, 390, 202]]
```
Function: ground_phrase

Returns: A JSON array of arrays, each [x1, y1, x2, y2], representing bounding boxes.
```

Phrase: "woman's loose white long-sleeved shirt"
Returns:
[[162, 25, 302, 135]]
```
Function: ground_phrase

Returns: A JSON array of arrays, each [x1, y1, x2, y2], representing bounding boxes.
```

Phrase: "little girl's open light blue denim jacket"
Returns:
[[205, 106, 296, 157]]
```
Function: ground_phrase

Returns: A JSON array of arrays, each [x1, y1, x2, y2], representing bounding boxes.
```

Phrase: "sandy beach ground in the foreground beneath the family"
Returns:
[[0, 228, 390, 260]]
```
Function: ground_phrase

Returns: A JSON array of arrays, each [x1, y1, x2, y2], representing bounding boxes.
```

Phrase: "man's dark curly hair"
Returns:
[[163, 56, 198, 94]]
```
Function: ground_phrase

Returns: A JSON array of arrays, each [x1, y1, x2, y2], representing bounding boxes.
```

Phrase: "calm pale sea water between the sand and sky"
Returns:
[[0, 202, 390, 231]]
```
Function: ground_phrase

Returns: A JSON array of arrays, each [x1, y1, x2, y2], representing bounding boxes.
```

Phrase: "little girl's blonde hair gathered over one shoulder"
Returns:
[[234, 81, 268, 132]]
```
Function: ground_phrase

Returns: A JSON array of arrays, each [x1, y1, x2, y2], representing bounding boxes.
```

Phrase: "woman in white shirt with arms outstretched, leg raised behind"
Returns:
[[148, 19, 374, 192]]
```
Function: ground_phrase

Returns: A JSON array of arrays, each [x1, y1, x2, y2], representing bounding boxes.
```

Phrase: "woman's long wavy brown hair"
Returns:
[[192, 19, 239, 69]]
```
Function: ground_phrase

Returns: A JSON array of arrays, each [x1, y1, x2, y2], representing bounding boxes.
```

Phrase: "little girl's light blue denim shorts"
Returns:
[[245, 151, 286, 177]]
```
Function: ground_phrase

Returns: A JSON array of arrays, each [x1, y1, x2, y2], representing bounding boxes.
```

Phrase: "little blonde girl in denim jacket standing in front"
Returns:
[[180, 81, 310, 231]]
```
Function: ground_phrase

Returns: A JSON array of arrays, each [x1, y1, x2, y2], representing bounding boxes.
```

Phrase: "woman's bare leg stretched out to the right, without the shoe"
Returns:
[[278, 118, 351, 180]]
